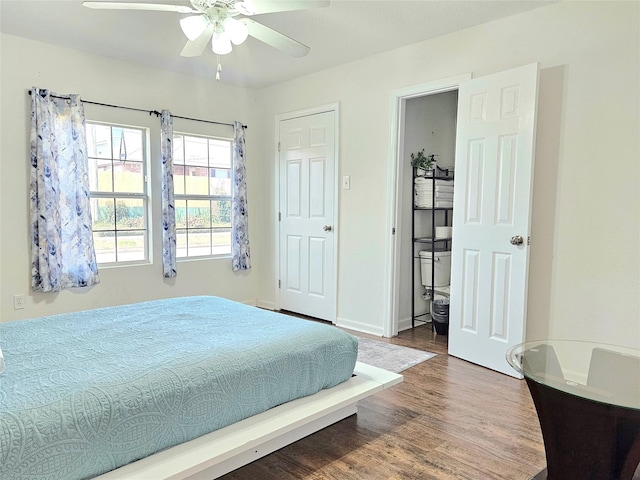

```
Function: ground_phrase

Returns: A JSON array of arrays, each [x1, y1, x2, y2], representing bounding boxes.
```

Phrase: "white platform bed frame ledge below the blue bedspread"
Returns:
[[96, 362, 404, 480]]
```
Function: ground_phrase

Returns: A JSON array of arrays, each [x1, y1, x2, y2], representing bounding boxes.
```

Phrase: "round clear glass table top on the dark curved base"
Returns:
[[506, 340, 640, 409]]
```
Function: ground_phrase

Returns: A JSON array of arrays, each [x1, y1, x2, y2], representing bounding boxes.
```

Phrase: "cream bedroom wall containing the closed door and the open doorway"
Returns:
[[255, 2, 640, 347]]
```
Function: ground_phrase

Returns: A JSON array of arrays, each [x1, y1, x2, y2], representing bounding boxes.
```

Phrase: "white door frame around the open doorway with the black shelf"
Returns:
[[383, 73, 472, 337]]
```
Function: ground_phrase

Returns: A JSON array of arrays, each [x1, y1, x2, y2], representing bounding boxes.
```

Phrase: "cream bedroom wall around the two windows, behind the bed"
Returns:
[[0, 34, 271, 321]]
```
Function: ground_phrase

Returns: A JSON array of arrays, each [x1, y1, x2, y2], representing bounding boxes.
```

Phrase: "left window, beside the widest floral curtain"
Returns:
[[86, 122, 149, 264]]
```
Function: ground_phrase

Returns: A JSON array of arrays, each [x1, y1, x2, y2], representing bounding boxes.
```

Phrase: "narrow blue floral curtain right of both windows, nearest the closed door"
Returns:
[[231, 122, 251, 270]]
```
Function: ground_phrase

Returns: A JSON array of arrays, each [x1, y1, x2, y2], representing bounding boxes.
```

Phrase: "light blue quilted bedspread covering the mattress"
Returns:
[[0, 297, 357, 480]]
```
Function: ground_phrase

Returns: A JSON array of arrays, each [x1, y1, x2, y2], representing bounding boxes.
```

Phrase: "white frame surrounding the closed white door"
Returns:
[[273, 102, 340, 325]]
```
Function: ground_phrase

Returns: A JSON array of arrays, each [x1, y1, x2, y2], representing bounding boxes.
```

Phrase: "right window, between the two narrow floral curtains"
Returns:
[[173, 134, 232, 258]]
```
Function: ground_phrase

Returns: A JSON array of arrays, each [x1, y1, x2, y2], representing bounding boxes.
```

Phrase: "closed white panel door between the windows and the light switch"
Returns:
[[279, 111, 336, 322]]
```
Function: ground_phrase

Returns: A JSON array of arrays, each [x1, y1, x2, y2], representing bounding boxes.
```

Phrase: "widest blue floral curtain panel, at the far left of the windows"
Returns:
[[30, 87, 99, 292]]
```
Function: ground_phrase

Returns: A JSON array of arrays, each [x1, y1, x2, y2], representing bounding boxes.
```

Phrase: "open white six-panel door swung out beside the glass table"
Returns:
[[449, 64, 538, 377]]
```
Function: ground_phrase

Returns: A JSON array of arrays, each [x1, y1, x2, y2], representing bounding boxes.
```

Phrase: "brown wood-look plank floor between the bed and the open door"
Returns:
[[222, 326, 545, 480]]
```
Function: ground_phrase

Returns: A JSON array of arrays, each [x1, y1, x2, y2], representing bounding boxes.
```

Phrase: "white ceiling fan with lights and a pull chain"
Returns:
[[83, 0, 329, 64]]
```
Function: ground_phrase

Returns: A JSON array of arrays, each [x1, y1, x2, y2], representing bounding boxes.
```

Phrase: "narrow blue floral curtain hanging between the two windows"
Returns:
[[160, 110, 178, 277]]
